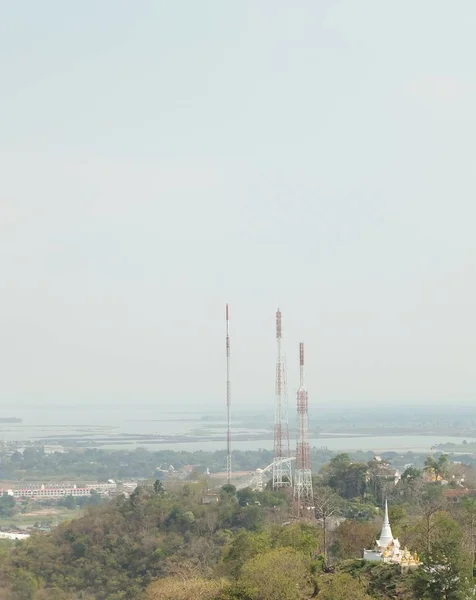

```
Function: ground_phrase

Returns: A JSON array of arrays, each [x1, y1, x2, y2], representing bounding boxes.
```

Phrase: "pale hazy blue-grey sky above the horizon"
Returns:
[[0, 0, 476, 413]]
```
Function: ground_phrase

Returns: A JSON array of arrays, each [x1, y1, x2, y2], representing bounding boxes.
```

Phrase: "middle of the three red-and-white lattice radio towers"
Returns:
[[273, 308, 292, 490]]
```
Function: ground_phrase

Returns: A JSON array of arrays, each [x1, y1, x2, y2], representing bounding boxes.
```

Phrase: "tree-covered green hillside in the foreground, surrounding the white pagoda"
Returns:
[[0, 455, 476, 600]]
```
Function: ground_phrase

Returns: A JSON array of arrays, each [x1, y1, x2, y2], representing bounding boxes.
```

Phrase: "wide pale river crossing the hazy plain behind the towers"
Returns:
[[0, 406, 475, 453]]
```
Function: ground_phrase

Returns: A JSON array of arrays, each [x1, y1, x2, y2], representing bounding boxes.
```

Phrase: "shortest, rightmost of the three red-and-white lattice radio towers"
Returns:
[[294, 343, 313, 514]]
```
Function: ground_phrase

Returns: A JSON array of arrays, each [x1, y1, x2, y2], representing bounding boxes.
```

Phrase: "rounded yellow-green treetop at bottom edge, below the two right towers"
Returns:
[[240, 548, 310, 600]]
